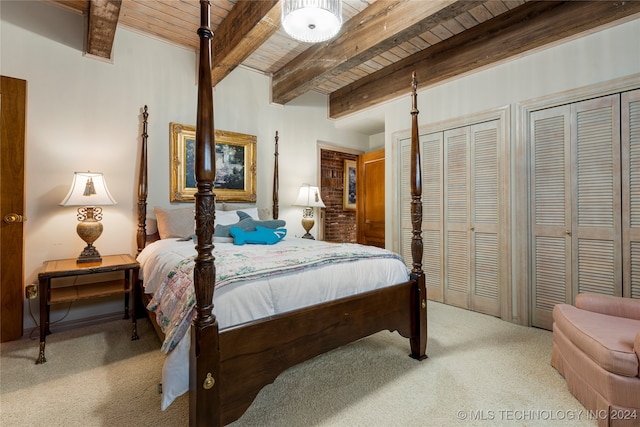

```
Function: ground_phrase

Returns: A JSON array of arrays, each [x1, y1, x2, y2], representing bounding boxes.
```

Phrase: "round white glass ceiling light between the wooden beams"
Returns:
[[282, 0, 342, 43]]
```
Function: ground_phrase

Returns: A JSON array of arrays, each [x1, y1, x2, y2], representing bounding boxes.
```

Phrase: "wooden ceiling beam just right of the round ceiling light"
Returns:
[[271, 0, 484, 104]]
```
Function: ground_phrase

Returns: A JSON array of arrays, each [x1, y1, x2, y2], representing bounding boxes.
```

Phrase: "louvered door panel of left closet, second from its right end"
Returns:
[[444, 127, 471, 308]]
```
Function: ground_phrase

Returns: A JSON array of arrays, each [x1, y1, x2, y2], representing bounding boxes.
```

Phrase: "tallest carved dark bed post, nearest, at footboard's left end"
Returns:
[[189, 0, 221, 426]]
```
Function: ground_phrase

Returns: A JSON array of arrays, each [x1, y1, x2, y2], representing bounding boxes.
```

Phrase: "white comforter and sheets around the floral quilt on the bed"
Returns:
[[138, 237, 409, 410]]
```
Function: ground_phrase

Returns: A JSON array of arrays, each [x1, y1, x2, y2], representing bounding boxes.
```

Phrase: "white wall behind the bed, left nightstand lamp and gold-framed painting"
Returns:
[[0, 0, 369, 328]]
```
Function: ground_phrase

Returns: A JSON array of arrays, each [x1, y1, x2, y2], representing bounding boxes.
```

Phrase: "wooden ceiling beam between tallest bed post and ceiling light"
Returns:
[[211, 0, 282, 86]]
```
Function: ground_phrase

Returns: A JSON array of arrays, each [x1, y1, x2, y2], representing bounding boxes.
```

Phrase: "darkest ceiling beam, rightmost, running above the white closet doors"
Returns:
[[329, 1, 640, 119]]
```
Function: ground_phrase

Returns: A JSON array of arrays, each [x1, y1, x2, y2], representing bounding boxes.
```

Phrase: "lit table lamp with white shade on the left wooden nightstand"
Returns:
[[60, 172, 116, 263]]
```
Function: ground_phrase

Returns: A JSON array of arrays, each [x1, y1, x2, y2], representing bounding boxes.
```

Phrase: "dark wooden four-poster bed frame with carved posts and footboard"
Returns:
[[137, 0, 427, 425]]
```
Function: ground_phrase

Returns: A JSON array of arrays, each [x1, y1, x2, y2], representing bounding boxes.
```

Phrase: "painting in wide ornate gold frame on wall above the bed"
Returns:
[[169, 122, 257, 202]]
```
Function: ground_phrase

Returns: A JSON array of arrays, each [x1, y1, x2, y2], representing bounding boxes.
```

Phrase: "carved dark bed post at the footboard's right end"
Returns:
[[410, 72, 427, 360]]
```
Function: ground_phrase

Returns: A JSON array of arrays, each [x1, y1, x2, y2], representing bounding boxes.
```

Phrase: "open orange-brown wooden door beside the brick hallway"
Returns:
[[356, 149, 385, 248]]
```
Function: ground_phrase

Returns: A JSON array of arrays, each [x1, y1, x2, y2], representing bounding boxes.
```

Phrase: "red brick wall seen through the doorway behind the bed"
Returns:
[[320, 150, 358, 243]]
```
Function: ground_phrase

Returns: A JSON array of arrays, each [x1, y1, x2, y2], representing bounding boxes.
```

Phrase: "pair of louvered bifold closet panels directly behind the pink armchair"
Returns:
[[530, 95, 622, 329]]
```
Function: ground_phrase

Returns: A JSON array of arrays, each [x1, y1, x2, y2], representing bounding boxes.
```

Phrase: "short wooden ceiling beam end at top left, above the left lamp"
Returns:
[[86, 0, 122, 59]]
